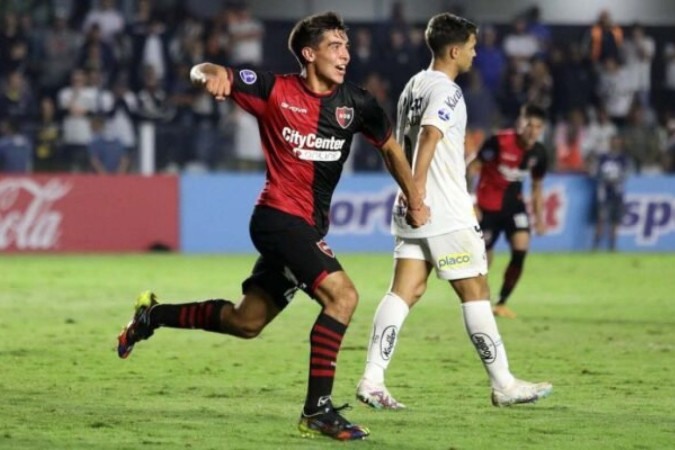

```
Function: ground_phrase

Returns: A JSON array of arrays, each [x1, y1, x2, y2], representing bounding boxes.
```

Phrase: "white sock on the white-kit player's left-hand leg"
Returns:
[[363, 292, 410, 384]]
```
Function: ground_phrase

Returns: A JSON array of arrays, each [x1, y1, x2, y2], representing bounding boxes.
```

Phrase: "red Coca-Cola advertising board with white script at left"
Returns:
[[0, 175, 179, 252]]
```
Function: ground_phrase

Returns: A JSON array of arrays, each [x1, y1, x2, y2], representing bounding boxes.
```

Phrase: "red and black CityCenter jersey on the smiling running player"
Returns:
[[230, 69, 392, 234]]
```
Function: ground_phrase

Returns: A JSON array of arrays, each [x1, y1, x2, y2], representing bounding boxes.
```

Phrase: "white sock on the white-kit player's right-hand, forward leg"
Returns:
[[462, 300, 514, 389]]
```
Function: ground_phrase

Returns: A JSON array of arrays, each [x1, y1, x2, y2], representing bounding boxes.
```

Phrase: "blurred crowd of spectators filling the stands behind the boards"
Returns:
[[0, 0, 675, 174]]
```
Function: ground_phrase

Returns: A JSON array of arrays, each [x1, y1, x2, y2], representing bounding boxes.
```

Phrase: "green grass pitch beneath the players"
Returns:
[[0, 254, 675, 450]]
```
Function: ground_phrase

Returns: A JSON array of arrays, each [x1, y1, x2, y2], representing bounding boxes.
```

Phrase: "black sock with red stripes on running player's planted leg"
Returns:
[[305, 313, 347, 414]]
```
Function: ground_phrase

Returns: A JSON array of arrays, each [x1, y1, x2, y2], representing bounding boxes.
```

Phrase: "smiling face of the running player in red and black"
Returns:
[[313, 30, 349, 88]]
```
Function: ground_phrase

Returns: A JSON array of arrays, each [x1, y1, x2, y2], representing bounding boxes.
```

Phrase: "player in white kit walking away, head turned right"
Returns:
[[356, 13, 552, 409]]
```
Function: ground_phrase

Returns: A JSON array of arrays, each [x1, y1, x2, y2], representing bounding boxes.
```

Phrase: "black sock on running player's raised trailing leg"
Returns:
[[150, 299, 232, 331]]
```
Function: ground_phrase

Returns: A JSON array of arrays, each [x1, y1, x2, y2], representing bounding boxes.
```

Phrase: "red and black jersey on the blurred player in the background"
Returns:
[[476, 130, 547, 211]]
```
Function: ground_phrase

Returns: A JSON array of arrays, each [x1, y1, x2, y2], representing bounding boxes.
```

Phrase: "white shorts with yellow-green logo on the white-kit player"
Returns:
[[394, 227, 487, 280]]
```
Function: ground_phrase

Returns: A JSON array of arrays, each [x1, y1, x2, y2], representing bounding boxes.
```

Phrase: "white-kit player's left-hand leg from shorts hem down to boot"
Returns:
[[356, 259, 431, 409]]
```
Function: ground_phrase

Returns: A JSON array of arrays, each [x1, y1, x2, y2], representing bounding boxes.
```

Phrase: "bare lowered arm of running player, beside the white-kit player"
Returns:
[[380, 136, 429, 228]]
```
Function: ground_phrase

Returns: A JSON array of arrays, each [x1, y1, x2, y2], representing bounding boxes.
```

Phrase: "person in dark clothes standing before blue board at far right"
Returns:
[[593, 135, 628, 251]]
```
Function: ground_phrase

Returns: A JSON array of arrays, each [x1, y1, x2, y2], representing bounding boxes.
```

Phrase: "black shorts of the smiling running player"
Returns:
[[242, 206, 342, 308]]
